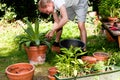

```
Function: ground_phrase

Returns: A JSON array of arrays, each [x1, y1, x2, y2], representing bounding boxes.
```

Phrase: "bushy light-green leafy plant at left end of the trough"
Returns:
[[56, 46, 86, 77]]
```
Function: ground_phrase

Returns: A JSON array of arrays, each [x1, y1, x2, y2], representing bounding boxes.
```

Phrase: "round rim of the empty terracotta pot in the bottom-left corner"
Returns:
[[5, 63, 35, 75]]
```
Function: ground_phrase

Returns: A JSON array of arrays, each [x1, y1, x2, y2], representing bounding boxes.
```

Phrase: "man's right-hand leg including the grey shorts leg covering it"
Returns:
[[74, 0, 88, 51]]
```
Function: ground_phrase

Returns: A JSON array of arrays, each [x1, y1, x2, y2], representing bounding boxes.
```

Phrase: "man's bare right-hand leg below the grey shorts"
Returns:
[[78, 22, 87, 51]]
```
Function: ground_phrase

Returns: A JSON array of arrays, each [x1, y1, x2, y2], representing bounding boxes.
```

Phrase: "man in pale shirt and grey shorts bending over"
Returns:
[[38, 0, 88, 50]]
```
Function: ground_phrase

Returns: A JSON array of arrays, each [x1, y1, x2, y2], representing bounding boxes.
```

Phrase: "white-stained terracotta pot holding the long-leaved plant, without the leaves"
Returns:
[[25, 45, 47, 64]]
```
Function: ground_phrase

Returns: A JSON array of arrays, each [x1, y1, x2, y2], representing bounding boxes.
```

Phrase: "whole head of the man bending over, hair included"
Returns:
[[38, 0, 54, 14]]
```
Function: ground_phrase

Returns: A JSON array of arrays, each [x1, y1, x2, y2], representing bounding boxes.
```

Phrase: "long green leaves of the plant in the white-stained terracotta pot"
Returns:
[[15, 18, 50, 47]]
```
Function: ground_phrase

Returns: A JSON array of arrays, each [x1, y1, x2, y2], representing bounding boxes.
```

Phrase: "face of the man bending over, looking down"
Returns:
[[39, 2, 54, 14]]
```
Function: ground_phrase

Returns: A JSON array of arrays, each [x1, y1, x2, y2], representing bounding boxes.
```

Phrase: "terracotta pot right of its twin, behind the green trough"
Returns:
[[93, 52, 109, 61]]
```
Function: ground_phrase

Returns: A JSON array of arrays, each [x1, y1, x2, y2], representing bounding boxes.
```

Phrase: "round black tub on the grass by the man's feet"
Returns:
[[59, 39, 85, 49]]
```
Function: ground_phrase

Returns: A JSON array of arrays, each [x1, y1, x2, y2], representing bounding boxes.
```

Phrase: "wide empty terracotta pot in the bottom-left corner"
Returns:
[[5, 63, 35, 80]]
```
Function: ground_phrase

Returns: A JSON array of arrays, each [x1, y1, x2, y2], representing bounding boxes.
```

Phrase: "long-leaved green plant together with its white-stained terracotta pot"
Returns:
[[15, 18, 50, 64]]
